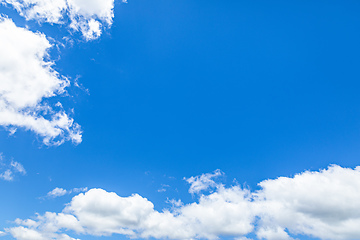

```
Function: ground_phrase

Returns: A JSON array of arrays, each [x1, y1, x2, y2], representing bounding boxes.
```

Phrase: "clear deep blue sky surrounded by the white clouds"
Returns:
[[0, 0, 360, 239]]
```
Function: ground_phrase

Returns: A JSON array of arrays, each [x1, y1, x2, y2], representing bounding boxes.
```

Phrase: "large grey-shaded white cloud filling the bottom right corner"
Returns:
[[253, 165, 360, 239]]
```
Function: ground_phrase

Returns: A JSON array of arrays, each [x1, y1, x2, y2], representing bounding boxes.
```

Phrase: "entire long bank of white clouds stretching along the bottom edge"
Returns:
[[5, 165, 360, 240]]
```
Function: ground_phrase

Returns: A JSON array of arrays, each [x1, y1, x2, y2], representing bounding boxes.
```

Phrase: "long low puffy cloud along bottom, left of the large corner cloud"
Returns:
[[8, 187, 253, 239]]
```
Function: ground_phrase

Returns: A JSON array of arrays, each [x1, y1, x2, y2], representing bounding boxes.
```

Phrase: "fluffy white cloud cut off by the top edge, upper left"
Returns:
[[0, 0, 126, 40]]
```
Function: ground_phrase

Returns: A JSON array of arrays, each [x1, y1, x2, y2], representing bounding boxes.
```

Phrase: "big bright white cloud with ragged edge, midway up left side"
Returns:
[[0, 17, 81, 145]]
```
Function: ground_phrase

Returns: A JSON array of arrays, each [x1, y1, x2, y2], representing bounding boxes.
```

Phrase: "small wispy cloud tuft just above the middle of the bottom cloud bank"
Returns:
[[185, 169, 223, 194]]
